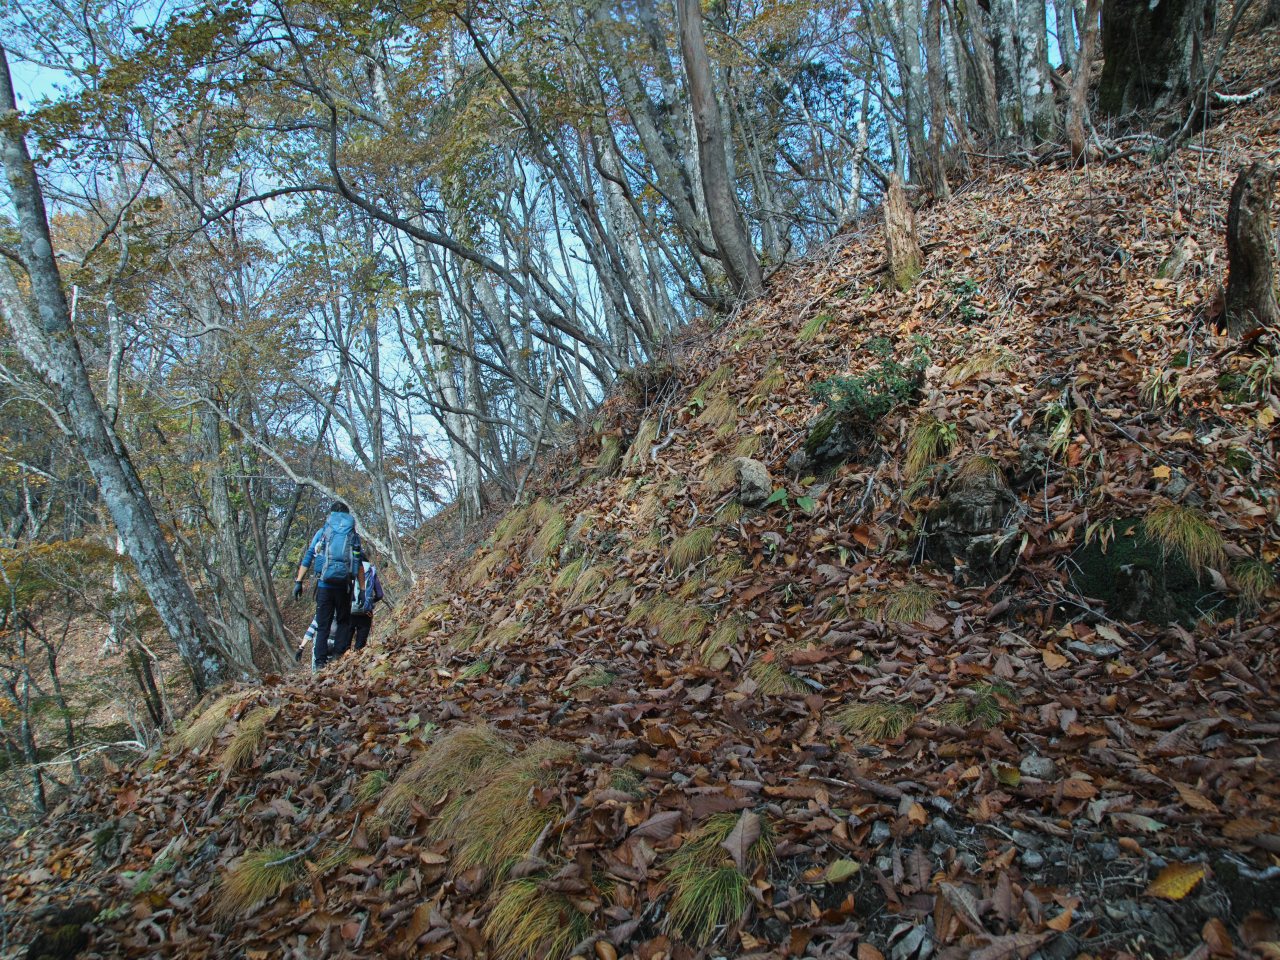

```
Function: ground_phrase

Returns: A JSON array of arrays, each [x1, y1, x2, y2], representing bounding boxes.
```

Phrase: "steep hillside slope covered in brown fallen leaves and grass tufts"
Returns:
[[10, 71, 1280, 960]]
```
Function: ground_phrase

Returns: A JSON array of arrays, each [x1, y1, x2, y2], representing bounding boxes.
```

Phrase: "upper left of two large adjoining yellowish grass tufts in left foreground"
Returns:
[[378, 724, 511, 823]]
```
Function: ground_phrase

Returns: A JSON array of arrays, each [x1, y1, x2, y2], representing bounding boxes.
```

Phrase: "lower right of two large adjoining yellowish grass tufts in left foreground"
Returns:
[[448, 740, 572, 876]]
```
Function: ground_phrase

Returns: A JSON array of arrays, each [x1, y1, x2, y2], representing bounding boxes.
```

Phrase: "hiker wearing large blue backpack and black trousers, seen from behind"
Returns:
[[293, 500, 365, 671]]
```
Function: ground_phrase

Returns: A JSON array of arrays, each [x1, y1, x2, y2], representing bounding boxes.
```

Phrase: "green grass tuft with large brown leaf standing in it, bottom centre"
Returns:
[[667, 813, 773, 947]]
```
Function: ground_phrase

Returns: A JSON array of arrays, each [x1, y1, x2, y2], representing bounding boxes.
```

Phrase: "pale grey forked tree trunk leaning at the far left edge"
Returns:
[[0, 46, 229, 692]]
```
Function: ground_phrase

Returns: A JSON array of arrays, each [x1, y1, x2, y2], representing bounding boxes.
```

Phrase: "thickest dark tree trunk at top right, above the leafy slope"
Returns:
[[1098, 0, 1216, 116]]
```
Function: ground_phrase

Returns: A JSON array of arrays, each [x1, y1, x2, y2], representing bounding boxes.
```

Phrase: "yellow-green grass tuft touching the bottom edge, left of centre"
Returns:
[[484, 877, 591, 960]]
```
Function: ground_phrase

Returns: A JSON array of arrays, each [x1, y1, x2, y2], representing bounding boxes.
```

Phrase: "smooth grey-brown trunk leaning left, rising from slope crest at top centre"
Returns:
[[676, 0, 764, 298]]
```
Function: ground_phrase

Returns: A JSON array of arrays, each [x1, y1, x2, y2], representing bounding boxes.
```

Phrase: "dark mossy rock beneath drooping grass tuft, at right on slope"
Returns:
[[1070, 517, 1230, 626]]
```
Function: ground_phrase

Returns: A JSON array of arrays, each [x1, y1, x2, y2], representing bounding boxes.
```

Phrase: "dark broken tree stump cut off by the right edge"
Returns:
[[1226, 163, 1280, 337]]
